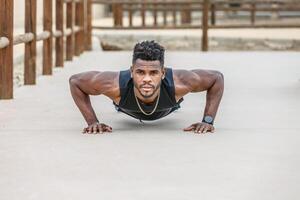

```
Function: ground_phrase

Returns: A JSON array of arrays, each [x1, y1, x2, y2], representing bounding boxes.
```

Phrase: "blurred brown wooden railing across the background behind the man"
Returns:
[[92, 0, 300, 51]]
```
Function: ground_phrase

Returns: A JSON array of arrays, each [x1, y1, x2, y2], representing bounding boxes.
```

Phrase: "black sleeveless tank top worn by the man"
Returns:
[[114, 68, 183, 120]]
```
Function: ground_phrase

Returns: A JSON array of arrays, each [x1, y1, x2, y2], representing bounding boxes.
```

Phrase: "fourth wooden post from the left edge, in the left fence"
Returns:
[[55, 0, 64, 67]]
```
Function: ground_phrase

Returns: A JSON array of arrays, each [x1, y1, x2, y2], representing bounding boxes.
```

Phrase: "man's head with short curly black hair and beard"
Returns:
[[131, 41, 165, 99]]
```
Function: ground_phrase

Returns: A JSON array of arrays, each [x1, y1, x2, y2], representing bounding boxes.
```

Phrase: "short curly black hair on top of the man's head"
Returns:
[[132, 40, 165, 66]]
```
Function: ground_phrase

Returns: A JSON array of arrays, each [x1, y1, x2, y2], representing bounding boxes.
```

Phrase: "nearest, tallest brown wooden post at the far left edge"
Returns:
[[0, 0, 14, 99]]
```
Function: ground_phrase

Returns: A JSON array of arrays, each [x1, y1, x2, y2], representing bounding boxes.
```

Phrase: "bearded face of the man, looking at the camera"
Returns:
[[131, 59, 165, 99]]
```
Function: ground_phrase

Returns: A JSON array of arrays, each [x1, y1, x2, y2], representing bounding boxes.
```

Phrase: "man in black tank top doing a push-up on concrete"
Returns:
[[70, 41, 224, 133]]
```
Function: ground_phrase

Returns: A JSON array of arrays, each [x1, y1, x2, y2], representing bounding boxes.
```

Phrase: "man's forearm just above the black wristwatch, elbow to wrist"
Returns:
[[204, 74, 224, 118]]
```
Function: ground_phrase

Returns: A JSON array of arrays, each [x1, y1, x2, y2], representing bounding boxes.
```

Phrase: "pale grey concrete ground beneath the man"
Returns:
[[0, 51, 300, 200]]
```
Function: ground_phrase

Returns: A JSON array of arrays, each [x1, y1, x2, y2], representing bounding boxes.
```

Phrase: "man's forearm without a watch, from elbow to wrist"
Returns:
[[70, 82, 98, 125]]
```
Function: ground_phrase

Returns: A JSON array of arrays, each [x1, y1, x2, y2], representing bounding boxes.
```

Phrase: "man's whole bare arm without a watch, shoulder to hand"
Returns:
[[69, 71, 118, 133]]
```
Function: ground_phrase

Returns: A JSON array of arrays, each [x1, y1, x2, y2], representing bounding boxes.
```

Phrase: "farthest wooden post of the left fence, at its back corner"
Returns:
[[85, 0, 92, 50]]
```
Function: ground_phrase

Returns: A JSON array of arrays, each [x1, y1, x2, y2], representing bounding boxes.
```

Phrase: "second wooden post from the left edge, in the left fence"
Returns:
[[24, 0, 36, 85]]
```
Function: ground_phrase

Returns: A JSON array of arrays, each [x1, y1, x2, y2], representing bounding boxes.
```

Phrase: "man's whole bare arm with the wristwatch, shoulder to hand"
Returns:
[[173, 70, 224, 133]]
